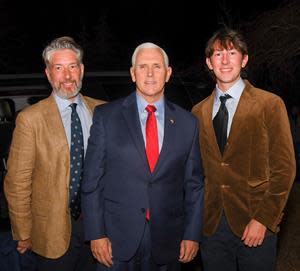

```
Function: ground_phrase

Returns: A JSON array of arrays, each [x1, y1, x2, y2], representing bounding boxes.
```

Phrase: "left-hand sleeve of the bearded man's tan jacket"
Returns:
[[4, 112, 35, 240]]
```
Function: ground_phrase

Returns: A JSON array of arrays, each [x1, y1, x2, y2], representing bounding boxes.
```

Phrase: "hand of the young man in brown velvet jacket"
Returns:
[[242, 219, 267, 247]]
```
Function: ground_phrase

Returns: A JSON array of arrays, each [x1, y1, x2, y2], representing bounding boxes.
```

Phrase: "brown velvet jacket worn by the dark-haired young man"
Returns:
[[192, 81, 295, 236]]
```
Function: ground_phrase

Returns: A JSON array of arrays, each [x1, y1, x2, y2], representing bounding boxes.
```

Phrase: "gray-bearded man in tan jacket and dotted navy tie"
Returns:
[[4, 37, 104, 271]]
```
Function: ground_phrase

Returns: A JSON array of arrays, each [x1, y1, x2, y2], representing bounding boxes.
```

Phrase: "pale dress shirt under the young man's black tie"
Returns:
[[212, 78, 245, 138]]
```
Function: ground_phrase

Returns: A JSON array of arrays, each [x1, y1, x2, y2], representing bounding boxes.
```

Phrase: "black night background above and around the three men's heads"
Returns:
[[0, 0, 300, 104]]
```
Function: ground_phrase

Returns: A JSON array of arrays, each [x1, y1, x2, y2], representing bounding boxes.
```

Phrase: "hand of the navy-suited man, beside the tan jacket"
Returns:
[[91, 238, 113, 267]]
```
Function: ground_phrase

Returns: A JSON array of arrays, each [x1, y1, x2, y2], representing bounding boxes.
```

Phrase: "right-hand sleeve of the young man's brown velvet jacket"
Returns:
[[254, 97, 296, 232]]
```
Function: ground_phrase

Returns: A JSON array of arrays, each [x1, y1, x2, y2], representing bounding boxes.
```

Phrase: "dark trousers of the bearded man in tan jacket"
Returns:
[[37, 218, 97, 271]]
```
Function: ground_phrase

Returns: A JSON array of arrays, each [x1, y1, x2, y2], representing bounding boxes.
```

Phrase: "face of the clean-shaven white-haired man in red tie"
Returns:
[[130, 48, 172, 103]]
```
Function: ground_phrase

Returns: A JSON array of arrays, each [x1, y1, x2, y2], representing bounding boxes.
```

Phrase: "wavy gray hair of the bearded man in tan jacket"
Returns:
[[42, 36, 83, 66]]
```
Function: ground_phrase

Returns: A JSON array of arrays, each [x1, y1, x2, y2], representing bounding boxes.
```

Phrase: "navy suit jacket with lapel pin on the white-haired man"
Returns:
[[82, 93, 203, 264]]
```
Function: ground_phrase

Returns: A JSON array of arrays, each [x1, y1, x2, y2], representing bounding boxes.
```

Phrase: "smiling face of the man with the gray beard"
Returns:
[[45, 49, 84, 101]]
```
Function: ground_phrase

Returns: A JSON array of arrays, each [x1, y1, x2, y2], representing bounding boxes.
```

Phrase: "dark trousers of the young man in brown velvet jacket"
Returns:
[[200, 215, 277, 271]]
